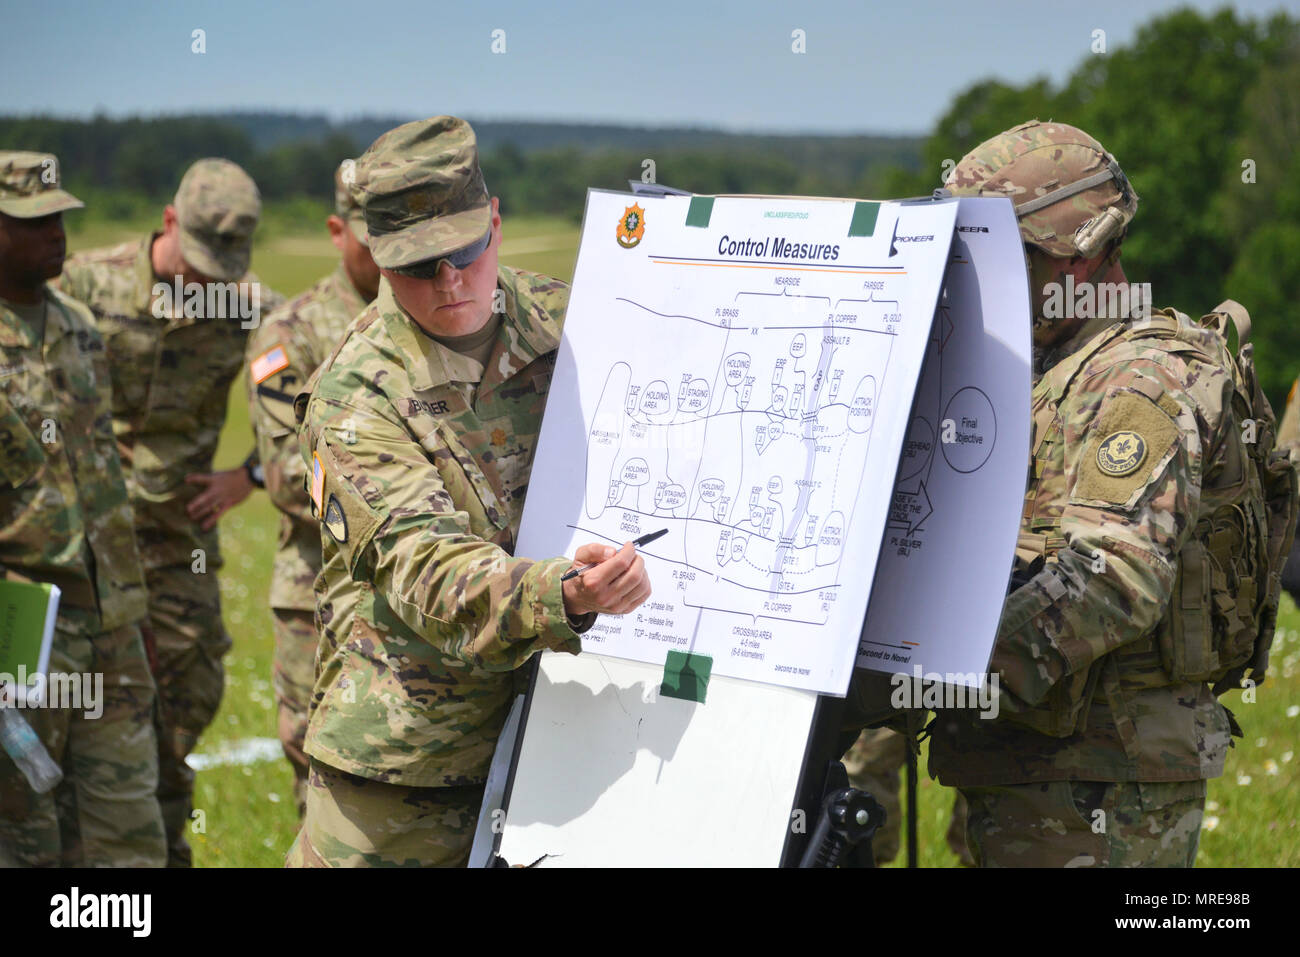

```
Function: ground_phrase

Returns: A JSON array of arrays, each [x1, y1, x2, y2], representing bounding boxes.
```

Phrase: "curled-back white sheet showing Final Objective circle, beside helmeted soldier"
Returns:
[[858, 199, 1032, 688]]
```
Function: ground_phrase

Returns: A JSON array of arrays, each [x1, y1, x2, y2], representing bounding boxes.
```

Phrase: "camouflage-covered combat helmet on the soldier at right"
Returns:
[[944, 120, 1138, 259]]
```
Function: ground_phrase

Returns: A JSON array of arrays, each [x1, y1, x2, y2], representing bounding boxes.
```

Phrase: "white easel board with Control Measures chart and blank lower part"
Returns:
[[488, 192, 982, 866]]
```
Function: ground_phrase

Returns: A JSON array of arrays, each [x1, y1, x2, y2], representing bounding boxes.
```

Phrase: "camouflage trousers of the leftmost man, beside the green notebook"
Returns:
[[0, 624, 166, 867]]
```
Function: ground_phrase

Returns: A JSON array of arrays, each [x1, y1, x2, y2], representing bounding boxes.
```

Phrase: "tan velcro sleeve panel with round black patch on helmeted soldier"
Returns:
[[1070, 391, 1179, 508]]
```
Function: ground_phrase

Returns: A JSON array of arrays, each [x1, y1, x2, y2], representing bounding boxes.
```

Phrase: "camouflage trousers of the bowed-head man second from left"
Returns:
[[146, 566, 230, 867]]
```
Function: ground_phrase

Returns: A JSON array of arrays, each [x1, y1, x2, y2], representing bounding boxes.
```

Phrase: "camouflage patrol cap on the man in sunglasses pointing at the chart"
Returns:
[[352, 116, 491, 269]]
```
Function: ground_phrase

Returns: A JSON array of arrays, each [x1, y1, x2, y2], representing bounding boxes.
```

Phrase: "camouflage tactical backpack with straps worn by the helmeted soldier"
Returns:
[[1009, 300, 1300, 737]]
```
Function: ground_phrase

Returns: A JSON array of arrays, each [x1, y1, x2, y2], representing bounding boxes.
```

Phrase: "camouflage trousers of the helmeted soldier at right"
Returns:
[[962, 781, 1205, 867]]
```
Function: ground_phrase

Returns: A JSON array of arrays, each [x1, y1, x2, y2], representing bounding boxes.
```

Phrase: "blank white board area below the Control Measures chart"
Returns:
[[491, 653, 818, 867]]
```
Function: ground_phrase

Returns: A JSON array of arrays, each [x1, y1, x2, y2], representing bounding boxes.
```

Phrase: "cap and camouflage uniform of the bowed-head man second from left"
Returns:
[[60, 160, 283, 865]]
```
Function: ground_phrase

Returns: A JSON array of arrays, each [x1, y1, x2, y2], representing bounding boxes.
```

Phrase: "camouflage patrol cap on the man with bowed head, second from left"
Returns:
[[174, 159, 261, 281]]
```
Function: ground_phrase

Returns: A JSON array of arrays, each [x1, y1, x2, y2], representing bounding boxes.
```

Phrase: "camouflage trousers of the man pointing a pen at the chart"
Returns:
[[285, 758, 484, 867]]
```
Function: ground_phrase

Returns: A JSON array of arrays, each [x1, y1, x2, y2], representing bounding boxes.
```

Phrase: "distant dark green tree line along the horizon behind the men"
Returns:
[[0, 113, 920, 221]]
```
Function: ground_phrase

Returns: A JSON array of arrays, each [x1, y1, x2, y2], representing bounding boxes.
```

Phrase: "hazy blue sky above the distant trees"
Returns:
[[0, 0, 1300, 133]]
